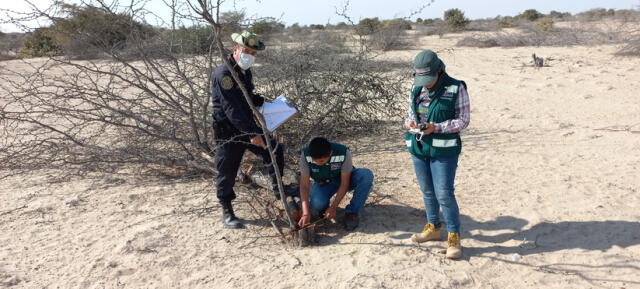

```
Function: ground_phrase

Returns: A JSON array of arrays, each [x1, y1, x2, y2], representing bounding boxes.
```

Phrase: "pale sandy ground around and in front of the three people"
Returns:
[[0, 31, 640, 289]]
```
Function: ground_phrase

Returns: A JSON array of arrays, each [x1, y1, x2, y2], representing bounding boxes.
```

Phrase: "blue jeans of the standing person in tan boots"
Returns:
[[412, 155, 460, 233]]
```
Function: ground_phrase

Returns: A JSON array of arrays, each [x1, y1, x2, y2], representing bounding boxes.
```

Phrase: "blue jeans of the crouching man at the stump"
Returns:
[[311, 168, 373, 213]]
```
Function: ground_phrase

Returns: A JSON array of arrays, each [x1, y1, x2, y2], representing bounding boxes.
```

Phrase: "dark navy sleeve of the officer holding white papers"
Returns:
[[213, 75, 262, 134]]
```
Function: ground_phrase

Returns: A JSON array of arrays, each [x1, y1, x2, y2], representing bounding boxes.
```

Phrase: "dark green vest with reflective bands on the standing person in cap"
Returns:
[[404, 73, 462, 158]]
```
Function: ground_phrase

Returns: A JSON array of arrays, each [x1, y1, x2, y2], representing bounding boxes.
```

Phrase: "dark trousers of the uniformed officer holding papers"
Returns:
[[214, 136, 284, 201]]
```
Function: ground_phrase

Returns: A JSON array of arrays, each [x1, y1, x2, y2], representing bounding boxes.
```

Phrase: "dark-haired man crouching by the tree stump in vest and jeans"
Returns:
[[298, 137, 373, 231]]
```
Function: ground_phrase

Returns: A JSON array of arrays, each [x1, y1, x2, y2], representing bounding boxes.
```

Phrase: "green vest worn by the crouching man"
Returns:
[[302, 143, 348, 183]]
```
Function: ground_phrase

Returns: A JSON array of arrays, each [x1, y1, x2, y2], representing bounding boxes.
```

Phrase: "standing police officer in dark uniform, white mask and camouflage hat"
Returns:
[[211, 31, 284, 228]]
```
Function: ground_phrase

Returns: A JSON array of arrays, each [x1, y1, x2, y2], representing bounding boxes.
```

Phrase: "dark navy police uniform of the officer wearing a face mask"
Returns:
[[211, 56, 284, 201]]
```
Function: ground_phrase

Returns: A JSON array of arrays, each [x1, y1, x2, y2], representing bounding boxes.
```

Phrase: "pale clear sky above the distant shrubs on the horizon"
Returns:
[[0, 0, 640, 32]]
